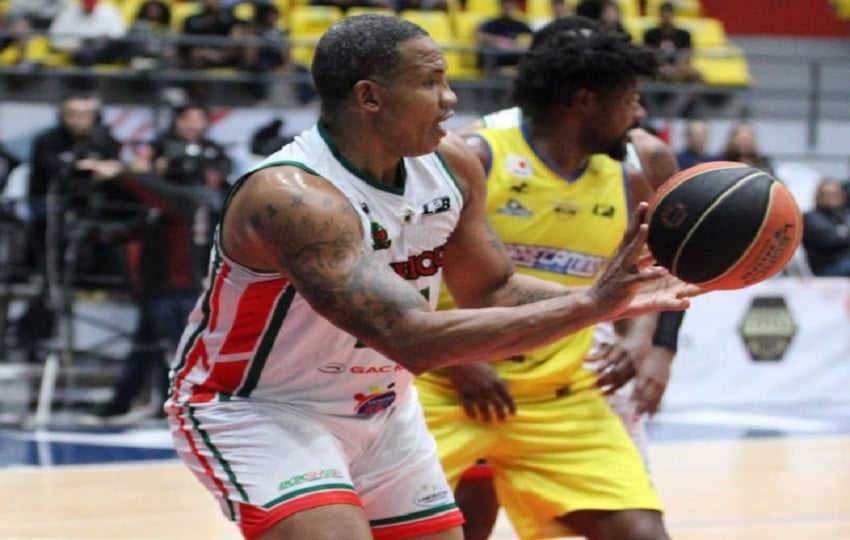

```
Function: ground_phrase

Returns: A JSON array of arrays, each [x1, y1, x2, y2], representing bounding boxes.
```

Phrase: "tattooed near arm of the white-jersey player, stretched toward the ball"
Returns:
[[217, 135, 687, 373]]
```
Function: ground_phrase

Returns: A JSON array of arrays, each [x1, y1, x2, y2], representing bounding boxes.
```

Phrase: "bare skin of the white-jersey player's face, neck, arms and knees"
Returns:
[[221, 37, 699, 540]]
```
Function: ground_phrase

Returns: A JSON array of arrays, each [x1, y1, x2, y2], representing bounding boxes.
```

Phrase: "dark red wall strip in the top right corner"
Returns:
[[700, 0, 850, 37]]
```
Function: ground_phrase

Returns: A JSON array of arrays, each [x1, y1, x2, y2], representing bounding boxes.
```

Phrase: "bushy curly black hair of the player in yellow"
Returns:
[[513, 30, 658, 120]]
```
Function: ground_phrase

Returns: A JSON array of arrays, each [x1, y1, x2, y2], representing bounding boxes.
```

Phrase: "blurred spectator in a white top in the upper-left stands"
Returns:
[[48, 0, 127, 66]]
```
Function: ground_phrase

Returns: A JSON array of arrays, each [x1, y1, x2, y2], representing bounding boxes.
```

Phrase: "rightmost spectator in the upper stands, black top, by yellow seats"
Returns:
[[643, 2, 702, 83]]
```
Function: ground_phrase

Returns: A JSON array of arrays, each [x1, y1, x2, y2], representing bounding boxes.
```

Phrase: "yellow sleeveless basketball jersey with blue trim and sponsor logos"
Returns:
[[428, 125, 629, 397]]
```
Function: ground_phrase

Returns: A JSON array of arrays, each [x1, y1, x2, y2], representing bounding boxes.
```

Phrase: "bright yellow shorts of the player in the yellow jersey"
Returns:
[[416, 379, 661, 540]]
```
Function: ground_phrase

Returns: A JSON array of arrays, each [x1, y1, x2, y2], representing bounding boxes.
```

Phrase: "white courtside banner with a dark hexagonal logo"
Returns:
[[664, 277, 850, 407]]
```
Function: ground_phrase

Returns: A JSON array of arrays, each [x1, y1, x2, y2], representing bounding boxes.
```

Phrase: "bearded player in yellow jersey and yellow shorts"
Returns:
[[417, 19, 667, 540]]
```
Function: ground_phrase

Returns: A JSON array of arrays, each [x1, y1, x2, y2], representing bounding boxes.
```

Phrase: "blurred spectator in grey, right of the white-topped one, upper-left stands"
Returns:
[[126, 0, 176, 69]]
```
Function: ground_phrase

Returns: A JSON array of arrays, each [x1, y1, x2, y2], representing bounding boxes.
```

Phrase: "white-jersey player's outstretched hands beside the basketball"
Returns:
[[589, 203, 702, 320]]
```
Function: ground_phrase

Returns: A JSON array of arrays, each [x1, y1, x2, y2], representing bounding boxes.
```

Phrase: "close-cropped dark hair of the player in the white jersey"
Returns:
[[311, 14, 428, 114]]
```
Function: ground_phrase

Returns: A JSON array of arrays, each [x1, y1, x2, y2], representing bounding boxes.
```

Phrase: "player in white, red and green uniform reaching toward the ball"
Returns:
[[166, 15, 699, 540]]
